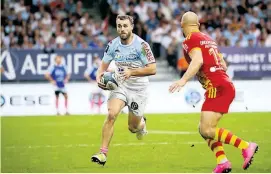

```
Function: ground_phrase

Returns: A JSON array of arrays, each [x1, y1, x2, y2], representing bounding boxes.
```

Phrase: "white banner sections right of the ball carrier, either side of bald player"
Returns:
[[146, 80, 271, 113]]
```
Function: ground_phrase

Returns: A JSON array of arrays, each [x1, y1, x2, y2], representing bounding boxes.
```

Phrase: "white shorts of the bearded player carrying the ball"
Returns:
[[108, 86, 148, 116]]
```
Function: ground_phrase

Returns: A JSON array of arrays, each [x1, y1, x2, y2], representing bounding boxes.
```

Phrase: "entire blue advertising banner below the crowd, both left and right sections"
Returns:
[[1, 47, 271, 82]]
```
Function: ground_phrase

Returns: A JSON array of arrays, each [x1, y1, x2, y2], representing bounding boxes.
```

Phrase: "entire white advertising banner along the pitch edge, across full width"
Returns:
[[1, 80, 271, 116]]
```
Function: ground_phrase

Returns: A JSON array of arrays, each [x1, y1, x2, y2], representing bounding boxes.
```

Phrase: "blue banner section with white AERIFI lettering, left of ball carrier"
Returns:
[[1, 49, 104, 82]]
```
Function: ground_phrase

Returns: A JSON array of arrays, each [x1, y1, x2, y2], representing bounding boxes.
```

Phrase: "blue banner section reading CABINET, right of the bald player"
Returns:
[[220, 47, 271, 79]]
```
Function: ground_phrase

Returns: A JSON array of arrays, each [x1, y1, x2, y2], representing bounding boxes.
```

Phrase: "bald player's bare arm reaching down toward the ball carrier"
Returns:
[[169, 49, 203, 93]]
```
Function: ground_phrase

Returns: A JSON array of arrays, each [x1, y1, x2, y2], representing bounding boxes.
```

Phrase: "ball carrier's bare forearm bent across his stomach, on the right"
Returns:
[[123, 63, 156, 79]]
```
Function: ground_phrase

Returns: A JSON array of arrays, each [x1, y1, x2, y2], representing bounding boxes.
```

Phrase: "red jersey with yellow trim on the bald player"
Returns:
[[183, 32, 230, 89]]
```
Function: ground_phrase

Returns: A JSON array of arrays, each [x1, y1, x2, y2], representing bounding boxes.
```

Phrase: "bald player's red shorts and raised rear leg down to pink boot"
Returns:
[[203, 83, 258, 169]]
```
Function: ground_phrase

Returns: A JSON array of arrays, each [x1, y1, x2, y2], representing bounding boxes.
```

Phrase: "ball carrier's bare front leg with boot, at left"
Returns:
[[91, 98, 125, 165]]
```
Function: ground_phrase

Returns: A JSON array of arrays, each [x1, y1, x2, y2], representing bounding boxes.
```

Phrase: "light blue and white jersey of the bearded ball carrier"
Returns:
[[103, 34, 155, 90]]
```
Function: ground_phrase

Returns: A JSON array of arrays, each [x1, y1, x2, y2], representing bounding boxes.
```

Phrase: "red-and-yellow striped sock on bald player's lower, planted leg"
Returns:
[[206, 139, 228, 164]]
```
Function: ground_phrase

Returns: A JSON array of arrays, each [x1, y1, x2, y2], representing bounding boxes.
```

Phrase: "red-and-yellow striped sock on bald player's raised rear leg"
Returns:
[[214, 128, 249, 149]]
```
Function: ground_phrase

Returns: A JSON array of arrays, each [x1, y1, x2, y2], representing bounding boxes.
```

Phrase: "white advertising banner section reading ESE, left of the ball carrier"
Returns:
[[1, 83, 108, 116]]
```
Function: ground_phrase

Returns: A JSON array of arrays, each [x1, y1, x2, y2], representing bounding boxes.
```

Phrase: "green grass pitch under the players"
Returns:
[[1, 113, 271, 173]]
